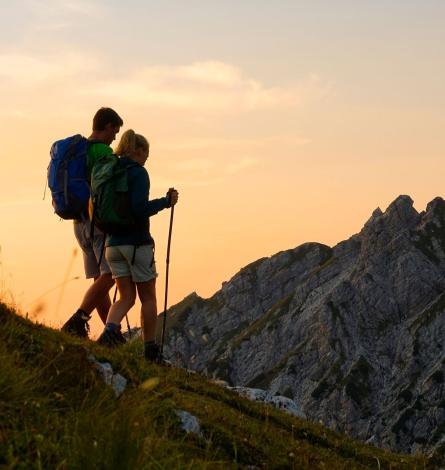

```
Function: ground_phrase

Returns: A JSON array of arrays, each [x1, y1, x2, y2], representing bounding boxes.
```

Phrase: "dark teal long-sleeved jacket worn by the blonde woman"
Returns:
[[106, 157, 170, 246]]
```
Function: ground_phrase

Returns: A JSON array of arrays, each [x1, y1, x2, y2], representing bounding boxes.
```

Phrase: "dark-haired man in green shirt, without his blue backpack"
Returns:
[[62, 108, 123, 338]]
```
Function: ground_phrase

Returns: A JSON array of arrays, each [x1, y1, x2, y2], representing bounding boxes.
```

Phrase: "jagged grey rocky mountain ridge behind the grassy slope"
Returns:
[[161, 196, 445, 452]]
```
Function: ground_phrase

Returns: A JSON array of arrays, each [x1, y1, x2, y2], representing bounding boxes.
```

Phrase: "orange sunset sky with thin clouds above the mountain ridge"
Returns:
[[0, 0, 445, 336]]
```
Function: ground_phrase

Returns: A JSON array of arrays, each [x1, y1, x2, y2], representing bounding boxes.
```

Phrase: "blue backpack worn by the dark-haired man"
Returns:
[[48, 134, 90, 219]]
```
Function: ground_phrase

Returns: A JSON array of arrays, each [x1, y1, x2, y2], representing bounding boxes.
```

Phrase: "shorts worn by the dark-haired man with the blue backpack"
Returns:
[[74, 220, 111, 279]]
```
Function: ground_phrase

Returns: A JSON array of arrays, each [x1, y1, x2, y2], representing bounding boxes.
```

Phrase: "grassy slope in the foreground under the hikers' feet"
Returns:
[[0, 304, 437, 470]]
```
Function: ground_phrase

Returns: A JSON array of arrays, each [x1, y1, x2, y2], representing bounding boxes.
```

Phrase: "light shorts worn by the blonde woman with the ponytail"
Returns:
[[105, 245, 158, 282]]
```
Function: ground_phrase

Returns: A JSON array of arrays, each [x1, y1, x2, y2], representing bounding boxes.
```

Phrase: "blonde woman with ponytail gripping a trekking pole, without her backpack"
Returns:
[[97, 129, 178, 361]]
